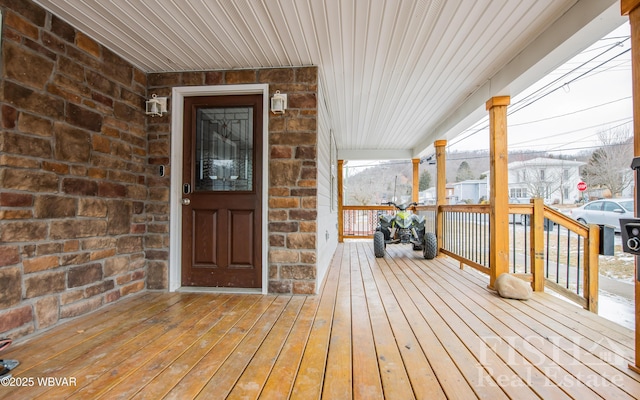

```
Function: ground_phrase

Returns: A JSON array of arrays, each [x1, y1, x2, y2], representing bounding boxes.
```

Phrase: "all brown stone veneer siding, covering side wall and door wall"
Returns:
[[0, 0, 317, 338]]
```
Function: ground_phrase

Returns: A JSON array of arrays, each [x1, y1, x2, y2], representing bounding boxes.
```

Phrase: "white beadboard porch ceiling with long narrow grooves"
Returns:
[[36, 0, 624, 159]]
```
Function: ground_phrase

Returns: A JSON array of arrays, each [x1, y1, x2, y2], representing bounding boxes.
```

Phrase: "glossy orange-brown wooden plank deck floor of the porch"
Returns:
[[0, 242, 640, 400]]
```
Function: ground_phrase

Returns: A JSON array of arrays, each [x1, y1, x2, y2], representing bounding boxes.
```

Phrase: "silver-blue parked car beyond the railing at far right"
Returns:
[[569, 199, 634, 232]]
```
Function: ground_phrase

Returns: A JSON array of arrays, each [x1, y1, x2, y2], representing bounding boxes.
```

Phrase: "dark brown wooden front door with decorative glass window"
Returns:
[[182, 95, 263, 288]]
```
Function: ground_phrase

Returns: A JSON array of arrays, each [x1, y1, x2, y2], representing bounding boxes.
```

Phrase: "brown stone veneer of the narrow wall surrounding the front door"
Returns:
[[147, 67, 318, 294]]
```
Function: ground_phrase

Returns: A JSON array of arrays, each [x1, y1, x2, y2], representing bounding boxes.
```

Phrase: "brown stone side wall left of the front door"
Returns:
[[0, 0, 151, 338]]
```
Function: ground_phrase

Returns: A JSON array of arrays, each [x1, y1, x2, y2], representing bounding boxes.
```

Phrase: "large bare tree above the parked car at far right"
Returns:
[[582, 127, 633, 197]]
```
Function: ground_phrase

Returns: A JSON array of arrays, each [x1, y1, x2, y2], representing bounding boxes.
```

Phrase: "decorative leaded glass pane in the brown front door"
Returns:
[[195, 107, 253, 192]]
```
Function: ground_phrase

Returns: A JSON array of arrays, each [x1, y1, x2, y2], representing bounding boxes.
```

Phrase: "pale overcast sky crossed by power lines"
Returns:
[[448, 24, 633, 154]]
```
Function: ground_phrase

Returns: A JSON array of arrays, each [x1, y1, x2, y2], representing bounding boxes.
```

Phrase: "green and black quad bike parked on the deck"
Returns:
[[373, 201, 437, 260]]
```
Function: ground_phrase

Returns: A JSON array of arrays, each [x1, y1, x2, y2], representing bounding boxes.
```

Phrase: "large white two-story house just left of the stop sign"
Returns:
[[509, 157, 584, 204]]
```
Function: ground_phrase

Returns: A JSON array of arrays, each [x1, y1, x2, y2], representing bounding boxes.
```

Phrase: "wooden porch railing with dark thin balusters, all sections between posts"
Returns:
[[340, 199, 600, 312]]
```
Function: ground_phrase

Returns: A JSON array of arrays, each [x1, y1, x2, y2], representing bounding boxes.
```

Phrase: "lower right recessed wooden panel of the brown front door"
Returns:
[[229, 210, 255, 268]]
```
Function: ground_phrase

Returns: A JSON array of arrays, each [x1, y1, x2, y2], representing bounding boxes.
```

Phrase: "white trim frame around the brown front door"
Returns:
[[169, 84, 269, 294]]
